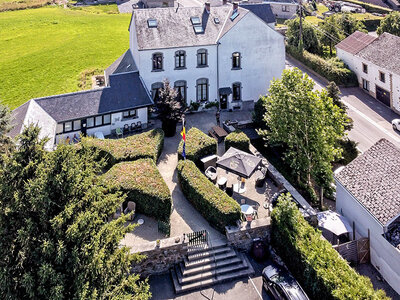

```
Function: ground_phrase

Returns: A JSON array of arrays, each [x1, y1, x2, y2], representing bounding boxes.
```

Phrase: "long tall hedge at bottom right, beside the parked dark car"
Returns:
[[271, 194, 389, 300]]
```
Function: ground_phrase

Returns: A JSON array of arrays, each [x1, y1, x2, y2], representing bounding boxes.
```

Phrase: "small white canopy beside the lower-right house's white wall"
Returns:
[[317, 210, 353, 236]]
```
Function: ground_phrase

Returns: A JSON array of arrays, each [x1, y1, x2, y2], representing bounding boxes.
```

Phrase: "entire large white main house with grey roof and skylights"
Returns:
[[130, 3, 285, 110]]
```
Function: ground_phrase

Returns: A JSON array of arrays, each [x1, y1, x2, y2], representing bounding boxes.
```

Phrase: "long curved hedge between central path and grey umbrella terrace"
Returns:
[[177, 160, 240, 232]]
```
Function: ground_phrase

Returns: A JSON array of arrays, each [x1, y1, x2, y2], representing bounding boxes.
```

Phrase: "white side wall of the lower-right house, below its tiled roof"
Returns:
[[336, 180, 400, 293]]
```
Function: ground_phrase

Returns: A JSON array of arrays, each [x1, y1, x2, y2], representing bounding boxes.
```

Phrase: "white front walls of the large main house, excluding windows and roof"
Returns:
[[130, 9, 285, 109]]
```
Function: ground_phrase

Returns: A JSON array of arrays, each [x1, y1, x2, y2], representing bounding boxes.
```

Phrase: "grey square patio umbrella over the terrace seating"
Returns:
[[217, 147, 261, 178]]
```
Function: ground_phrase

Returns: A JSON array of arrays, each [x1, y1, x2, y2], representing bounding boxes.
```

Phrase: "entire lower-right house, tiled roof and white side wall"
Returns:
[[335, 139, 400, 293]]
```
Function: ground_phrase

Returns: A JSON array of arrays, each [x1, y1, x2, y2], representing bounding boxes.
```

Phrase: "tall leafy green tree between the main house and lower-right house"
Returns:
[[259, 68, 346, 200]]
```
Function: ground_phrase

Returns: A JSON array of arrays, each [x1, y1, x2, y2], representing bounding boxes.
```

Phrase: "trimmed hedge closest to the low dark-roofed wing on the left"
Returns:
[[82, 128, 164, 167]]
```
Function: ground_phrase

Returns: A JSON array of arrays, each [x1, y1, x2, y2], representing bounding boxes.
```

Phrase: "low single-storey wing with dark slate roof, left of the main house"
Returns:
[[10, 70, 153, 150]]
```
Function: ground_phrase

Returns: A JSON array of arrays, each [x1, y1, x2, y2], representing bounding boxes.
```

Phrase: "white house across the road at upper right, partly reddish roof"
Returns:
[[336, 31, 400, 113]]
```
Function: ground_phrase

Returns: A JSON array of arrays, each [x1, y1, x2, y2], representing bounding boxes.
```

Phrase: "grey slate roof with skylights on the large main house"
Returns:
[[133, 5, 249, 50]]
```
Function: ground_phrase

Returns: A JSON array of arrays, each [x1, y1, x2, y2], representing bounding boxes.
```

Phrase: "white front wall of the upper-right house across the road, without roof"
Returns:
[[336, 48, 400, 113]]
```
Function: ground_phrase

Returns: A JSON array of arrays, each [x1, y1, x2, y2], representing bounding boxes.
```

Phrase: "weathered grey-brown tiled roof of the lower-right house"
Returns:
[[335, 139, 400, 225]]
